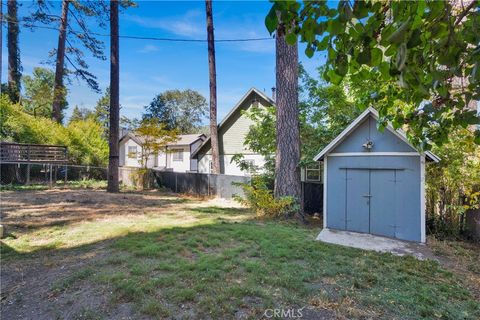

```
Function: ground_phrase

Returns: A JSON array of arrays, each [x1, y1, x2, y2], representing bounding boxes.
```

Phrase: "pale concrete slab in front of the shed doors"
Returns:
[[317, 229, 435, 260]]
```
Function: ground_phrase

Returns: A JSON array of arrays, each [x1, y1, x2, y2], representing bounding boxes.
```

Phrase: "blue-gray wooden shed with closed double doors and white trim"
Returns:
[[314, 108, 440, 242]]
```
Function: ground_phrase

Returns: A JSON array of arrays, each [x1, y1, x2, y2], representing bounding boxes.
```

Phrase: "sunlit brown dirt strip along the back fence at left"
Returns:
[[0, 189, 188, 232]]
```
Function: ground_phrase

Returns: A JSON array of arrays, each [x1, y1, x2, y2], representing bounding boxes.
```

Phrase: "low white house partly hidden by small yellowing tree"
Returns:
[[119, 132, 206, 172]]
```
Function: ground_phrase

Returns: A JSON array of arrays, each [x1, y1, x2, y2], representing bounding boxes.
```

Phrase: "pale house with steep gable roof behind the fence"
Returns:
[[192, 88, 275, 176]]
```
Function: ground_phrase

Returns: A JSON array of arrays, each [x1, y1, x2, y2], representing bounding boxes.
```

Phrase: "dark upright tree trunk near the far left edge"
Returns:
[[7, 0, 21, 103]]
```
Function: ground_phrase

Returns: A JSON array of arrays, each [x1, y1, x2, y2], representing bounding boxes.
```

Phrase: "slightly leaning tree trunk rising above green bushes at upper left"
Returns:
[[52, 0, 70, 123]]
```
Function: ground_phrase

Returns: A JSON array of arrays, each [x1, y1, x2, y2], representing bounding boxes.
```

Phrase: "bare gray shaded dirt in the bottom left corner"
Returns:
[[1, 243, 115, 320]]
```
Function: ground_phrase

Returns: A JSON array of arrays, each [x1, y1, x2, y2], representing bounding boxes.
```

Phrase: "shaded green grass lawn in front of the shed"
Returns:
[[97, 220, 480, 319]]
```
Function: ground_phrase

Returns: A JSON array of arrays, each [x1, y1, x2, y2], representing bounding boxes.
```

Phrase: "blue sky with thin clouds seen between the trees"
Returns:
[[2, 1, 324, 119]]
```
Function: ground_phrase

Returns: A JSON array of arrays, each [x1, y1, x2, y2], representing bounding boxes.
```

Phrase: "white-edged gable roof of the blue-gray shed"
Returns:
[[313, 107, 440, 162]]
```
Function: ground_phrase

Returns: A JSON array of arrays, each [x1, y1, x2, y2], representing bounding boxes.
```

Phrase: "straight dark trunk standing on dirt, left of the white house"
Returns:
[[107, 1, 120, 192]]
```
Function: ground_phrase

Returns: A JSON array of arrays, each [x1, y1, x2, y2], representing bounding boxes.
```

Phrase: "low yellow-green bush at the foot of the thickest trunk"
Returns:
[[235, 175, 299, 217]]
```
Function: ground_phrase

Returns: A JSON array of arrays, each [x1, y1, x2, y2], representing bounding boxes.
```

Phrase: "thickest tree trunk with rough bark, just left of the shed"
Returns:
[[274, 24, 303, 218]]
